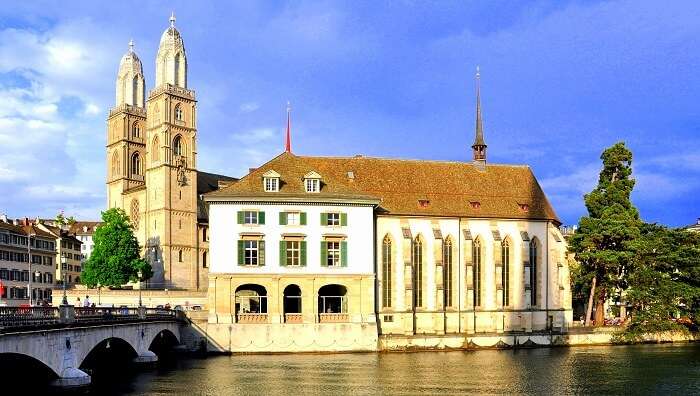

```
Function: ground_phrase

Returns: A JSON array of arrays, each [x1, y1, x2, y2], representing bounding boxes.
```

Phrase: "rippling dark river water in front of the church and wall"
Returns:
[[90, 344, 700, 396]]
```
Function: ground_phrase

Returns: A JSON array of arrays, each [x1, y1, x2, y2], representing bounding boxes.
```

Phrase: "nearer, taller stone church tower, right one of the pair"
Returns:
[[143, 15, 201, 289]]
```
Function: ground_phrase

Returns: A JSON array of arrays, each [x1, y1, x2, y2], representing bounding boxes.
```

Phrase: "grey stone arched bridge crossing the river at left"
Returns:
[[0, 308, 180, 387]]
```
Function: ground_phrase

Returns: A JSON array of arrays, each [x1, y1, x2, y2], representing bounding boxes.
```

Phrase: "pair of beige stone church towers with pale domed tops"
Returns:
[[107, 15, 211, 290]]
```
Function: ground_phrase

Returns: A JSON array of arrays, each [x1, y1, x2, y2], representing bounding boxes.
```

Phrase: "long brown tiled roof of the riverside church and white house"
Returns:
[[206, 153, 559, 222]]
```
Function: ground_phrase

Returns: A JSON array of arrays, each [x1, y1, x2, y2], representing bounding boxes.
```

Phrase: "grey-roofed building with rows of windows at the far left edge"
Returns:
[[0, 216, 56, 306]]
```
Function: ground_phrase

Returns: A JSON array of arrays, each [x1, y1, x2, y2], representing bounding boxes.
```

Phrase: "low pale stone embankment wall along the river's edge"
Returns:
[[182, 318, 700, 354]]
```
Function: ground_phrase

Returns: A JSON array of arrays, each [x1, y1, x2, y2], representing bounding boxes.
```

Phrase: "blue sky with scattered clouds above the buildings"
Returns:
[[0, 0, 700, 226]]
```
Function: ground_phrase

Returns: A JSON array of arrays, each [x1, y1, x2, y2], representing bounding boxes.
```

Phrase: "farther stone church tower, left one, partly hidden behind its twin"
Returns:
[[107, 41, 146, 213]]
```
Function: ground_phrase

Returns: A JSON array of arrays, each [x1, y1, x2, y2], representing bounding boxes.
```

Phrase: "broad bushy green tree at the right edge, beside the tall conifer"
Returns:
[[625, 224, 700, 340]]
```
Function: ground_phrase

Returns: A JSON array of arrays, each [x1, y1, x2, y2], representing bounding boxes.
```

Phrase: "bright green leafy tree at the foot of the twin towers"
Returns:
[[81, 208, 153, 287]]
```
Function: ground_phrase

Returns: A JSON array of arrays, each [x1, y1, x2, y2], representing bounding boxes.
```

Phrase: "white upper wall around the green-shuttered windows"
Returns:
[[209, 203, 374, 274]]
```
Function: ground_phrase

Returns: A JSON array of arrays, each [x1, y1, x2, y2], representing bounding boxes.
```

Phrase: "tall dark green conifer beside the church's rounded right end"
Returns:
[[569, 142, 641, 326]]
